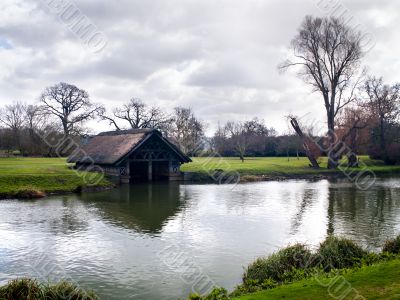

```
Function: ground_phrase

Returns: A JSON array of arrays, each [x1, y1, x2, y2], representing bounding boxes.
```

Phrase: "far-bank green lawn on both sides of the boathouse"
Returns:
[[0, 156, 400, 198]]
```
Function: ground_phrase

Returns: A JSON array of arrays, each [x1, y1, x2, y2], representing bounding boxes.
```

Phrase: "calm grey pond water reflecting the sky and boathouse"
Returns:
[[0, 178, 400, 299]]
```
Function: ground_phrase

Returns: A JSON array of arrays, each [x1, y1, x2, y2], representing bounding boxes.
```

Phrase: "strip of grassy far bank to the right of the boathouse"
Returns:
[[182, 156, 400, 179]]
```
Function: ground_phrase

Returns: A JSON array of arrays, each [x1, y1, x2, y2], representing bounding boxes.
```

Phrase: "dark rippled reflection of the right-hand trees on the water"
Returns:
[[327, 179, 400, 250]]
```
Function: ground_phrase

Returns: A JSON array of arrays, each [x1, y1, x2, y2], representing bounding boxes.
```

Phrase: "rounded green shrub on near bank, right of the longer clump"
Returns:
[[315, 236, 367, 271]]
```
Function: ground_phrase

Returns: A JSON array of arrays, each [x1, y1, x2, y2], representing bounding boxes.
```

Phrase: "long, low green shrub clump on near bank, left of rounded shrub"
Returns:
[[243, 244, 312, 284]]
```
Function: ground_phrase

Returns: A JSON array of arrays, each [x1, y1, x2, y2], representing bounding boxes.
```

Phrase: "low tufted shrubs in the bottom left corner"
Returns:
[[0, 278, 100, 300]]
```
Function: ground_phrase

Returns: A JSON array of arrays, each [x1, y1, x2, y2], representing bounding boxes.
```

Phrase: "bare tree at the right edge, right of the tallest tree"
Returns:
[[364, 77, 400, 152]]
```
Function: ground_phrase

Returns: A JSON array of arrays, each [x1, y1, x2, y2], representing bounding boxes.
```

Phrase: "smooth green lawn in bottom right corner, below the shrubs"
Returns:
[[234, 259, 400, 300]]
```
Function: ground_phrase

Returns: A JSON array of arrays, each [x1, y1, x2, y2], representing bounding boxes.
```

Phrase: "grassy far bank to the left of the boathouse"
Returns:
[[0, 158, 111, 198]]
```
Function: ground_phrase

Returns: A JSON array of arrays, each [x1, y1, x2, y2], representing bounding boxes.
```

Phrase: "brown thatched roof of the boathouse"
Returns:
[[68, 129, 191, 165]]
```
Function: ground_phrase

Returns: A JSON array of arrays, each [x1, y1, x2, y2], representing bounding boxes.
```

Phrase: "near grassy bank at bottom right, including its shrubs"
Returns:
[[189, 235, 400, 300]]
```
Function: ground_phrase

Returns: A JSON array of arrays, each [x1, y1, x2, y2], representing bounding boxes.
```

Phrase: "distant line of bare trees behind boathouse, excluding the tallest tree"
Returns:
[[0, 78, 400, 164]]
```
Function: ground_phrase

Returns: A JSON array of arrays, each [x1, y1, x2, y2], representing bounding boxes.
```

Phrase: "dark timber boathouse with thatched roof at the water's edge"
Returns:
[[68, 129, 191, 183]]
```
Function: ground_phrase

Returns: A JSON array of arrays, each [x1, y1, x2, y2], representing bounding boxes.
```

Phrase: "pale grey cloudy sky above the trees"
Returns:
[[0, 0, 400, 133]]
